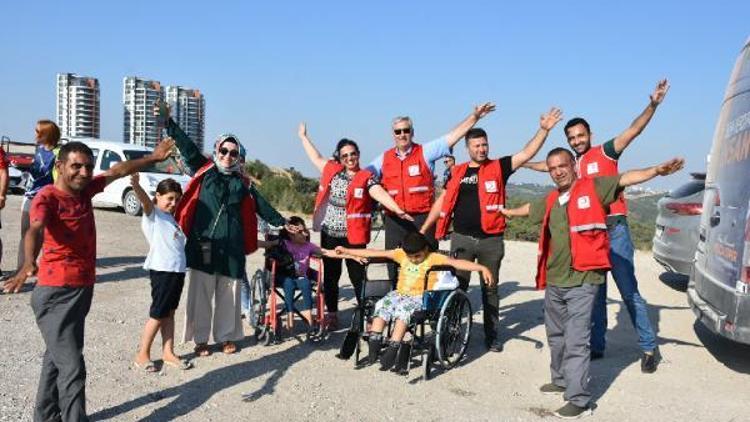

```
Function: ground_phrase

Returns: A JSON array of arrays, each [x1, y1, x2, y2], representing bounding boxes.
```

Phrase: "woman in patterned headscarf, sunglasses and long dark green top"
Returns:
[[155, 103, 285, 357]]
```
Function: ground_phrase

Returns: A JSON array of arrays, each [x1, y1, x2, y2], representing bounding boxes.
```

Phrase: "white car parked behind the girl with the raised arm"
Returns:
[[75, 138, 190, 215]]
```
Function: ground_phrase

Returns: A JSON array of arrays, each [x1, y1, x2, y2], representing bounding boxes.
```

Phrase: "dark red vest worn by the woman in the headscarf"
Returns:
[[174, 161, 258, 255]]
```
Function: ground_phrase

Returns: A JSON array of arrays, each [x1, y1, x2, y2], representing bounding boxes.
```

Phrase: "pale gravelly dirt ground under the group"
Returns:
[[0, 196, 750, 421]]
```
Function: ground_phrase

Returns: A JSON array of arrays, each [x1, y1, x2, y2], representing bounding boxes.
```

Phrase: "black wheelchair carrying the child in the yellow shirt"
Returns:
[[339, 259, 473, 380]]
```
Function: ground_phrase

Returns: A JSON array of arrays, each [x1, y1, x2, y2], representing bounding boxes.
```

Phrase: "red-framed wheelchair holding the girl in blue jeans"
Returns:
[[250, 256, 327, 346]]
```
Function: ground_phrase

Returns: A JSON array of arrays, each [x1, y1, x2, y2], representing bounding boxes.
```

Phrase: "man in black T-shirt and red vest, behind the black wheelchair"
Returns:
[[420, 108, 562, 352]]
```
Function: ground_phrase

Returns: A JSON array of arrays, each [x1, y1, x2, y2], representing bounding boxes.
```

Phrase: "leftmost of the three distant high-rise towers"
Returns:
[[56, 73, 100, 138]]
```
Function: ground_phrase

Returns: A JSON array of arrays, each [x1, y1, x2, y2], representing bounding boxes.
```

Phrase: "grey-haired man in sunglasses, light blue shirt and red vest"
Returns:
[[367, 102, 495, 282]]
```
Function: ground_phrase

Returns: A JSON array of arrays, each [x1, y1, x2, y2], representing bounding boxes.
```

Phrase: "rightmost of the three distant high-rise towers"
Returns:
[[166, 85, 206, 151]]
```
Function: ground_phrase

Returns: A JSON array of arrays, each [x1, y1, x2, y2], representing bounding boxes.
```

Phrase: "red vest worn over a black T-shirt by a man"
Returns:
[[435, 160, 505, 239]]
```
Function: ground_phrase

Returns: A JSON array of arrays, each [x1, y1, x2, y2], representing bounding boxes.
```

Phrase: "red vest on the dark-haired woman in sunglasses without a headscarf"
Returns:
[[313, 161, 373, 245]]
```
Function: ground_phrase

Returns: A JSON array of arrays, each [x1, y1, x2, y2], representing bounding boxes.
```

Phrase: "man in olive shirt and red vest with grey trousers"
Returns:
[[503, 148, 684, 418]]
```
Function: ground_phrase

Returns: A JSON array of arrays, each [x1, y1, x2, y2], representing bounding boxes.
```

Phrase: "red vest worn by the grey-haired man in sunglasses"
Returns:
[[381, 144, 435, 214]]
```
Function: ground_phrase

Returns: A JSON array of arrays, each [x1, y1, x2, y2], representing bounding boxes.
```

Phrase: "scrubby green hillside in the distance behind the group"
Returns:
[[247, 160, 663, 249]]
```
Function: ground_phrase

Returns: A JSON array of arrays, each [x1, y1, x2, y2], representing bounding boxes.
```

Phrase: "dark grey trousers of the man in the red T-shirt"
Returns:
[[31, 286, 94, 422]]
